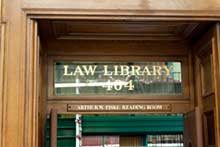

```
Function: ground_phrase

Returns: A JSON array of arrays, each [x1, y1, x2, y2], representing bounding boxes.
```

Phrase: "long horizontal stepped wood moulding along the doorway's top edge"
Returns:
[[22, 7, 220, 21]]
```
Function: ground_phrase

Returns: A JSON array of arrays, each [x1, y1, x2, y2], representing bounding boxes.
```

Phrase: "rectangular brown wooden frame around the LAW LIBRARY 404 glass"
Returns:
[[48, 55, 190, 102]]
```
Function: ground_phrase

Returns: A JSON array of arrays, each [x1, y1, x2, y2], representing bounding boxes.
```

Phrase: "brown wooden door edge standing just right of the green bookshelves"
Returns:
[[184, 107, 203, 147]]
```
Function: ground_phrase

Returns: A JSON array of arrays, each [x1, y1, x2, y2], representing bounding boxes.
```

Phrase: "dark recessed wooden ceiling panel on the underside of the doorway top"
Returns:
[[39, 20, 210, 41]]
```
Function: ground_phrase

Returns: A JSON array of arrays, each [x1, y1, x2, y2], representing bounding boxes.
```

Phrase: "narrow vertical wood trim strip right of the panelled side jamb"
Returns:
[[212, 23, 220, 147]]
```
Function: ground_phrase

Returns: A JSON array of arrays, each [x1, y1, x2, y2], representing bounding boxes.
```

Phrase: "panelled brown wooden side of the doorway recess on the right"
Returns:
[[194, 23, 220, 147]]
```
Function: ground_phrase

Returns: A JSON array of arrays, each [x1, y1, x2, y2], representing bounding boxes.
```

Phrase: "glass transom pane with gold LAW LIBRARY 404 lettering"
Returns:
[[54, 61, 182, 96]]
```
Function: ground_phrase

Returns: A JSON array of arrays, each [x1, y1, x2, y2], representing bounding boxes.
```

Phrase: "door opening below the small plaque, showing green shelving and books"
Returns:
[[46, 114, 184, 147]]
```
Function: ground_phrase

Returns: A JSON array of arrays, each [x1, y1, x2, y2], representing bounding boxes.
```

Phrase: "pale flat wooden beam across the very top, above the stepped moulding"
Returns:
[[23, 0, 220, 11]]
